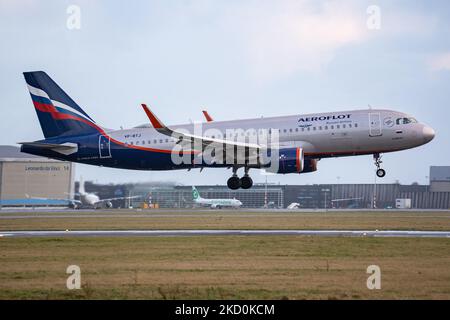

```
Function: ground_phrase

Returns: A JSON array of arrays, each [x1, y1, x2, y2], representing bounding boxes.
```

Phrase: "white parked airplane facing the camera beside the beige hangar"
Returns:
[[26, 177, 140, 209]]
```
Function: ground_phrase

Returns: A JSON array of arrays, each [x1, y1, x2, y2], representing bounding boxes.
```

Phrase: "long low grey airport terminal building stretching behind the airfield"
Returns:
[[86, 167, 450, 209]]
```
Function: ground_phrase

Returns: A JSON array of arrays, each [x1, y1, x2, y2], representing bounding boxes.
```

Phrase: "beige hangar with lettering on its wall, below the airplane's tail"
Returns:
[[0, 146, 74, 206]]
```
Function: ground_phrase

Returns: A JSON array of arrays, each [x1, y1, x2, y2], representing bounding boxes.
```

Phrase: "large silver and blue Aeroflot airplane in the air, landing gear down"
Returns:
[[19, 71, 435, 190]]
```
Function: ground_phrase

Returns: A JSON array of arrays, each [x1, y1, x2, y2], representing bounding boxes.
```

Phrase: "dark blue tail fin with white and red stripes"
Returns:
[[23, 71, 99, 138]]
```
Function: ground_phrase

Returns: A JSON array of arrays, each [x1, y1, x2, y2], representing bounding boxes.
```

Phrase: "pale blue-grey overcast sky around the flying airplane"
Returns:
[[0, 0, 450, 184]]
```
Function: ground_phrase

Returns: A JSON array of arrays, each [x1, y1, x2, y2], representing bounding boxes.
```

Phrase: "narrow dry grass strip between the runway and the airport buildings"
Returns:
[[0, 211, 450, 231]]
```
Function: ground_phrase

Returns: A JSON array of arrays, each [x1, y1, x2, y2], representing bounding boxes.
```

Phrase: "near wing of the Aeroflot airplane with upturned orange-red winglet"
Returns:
[[142, 104, 267, 164]]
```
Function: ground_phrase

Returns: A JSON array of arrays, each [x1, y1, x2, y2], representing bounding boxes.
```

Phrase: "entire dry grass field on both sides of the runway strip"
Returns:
[[0, 211, 450, 299]]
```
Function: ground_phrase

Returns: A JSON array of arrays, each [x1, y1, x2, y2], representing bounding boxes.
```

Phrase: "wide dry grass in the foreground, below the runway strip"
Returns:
[[0, 236, 450, 299]]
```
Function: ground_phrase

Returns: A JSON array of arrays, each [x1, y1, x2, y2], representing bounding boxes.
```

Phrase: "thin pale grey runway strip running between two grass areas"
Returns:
[[0, 230, 450, 238]]
